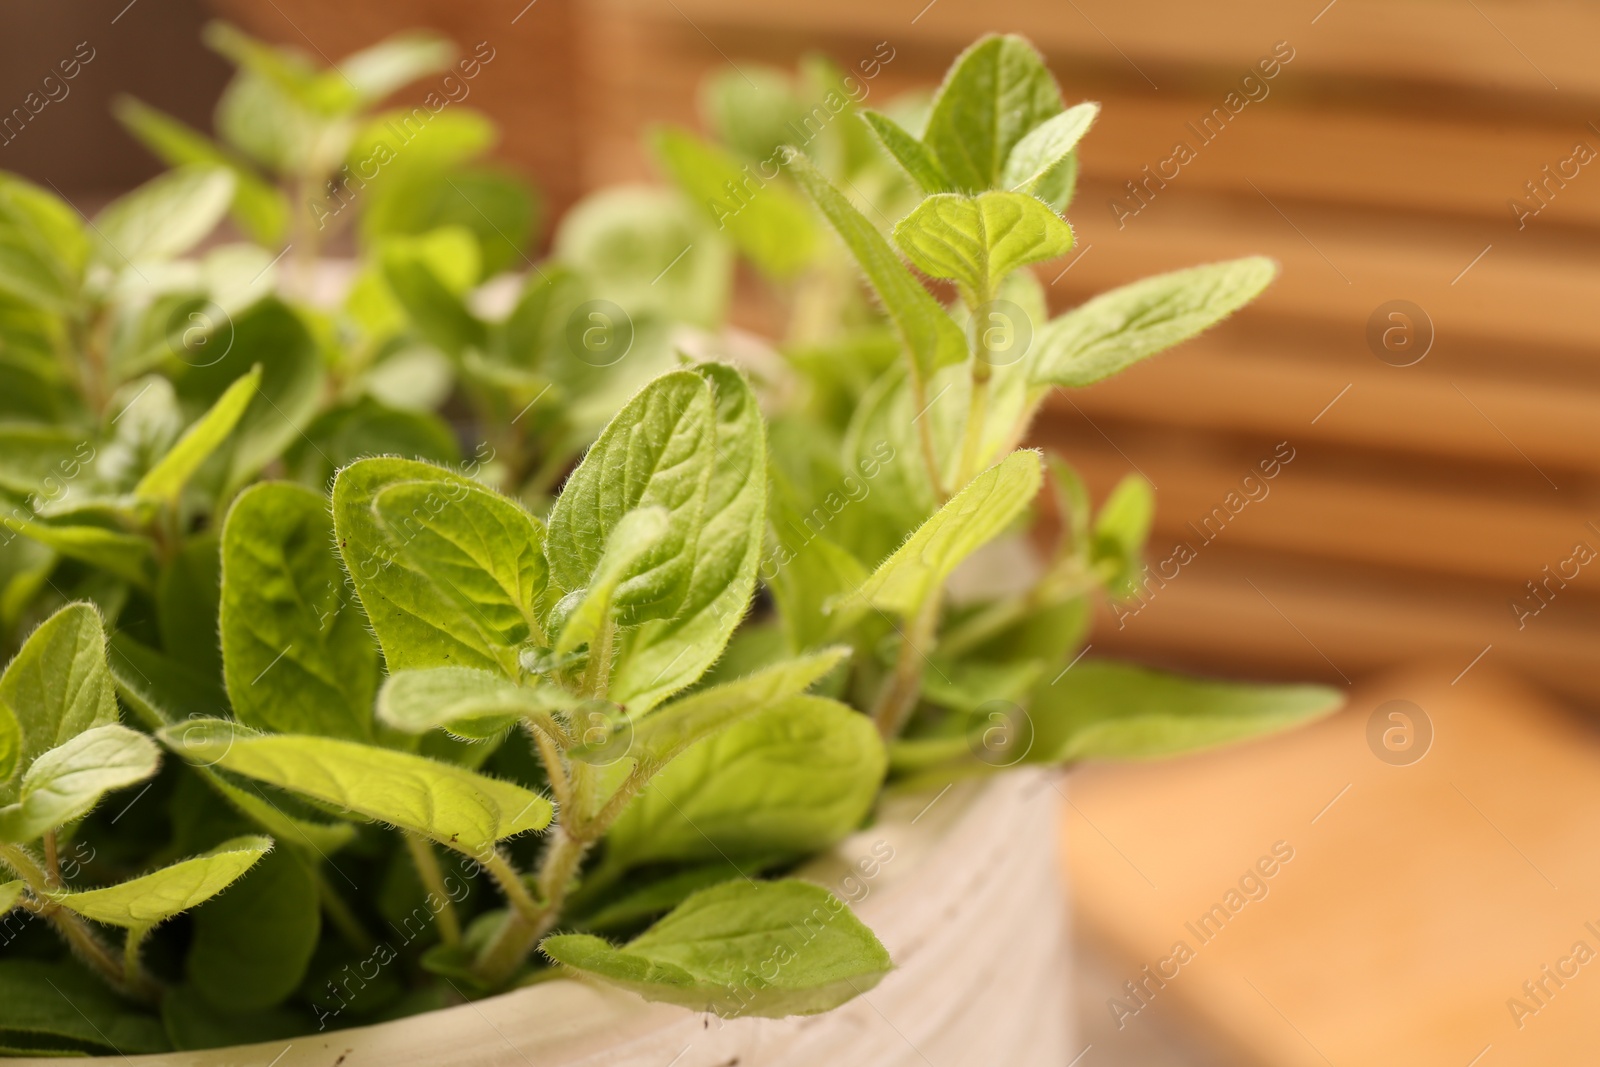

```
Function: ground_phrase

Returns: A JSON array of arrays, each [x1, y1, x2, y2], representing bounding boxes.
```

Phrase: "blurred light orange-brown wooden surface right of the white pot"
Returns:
[[1067, 665, 1600, 1067]]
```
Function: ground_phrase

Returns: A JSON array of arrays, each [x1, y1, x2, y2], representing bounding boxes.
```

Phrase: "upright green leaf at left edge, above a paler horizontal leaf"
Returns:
[[0, 603, 117, 803]]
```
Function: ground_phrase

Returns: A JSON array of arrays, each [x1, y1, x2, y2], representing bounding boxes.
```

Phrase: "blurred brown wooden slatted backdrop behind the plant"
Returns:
[[184, 0, 1600, 702]]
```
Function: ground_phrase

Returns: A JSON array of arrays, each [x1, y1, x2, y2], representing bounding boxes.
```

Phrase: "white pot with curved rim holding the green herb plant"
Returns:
[[46, 768, 1072, 1067]]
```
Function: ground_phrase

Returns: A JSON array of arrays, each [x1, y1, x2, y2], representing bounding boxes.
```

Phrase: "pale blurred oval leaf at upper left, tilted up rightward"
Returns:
[[94, 165, 234, 269]]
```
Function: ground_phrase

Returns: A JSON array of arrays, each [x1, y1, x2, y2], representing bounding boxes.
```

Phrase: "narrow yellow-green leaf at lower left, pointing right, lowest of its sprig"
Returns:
[[50, 837, 272, 928]]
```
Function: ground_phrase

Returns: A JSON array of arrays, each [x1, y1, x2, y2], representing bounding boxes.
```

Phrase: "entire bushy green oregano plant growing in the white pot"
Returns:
[[0, 29, 1338, 1053]]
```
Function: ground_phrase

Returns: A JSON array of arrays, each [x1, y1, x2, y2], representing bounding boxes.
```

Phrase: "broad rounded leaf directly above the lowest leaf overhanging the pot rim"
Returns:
[[605, 696, 886, 867]]
